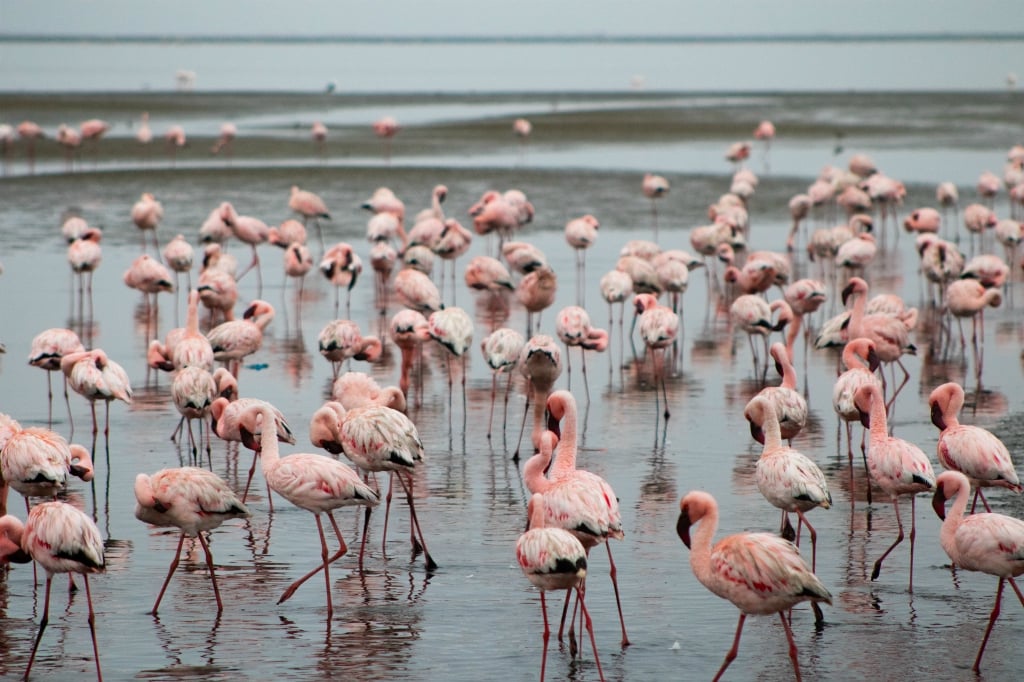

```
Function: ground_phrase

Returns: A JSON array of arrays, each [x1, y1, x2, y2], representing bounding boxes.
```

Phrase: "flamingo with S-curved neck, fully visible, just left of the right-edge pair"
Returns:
[[854, 384, 935, 592]]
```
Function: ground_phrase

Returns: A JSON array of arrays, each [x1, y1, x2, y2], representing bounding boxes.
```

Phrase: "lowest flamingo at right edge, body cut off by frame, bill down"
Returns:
[[932, 471, 1024, 674]]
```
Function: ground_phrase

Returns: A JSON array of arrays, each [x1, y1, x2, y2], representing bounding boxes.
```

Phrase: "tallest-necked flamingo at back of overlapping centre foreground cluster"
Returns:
[[540, 390, 630, 647]]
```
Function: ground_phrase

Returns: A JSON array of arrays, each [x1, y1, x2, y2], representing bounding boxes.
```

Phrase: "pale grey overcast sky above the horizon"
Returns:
[[6, 0, 1024, 35]]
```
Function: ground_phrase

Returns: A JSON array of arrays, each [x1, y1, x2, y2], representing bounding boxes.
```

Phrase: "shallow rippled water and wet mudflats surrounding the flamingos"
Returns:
[[0, 95, 1024, 680]]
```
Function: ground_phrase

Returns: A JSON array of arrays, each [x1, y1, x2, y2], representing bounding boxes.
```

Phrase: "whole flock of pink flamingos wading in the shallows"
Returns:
[[0, 100, 1024, 680]]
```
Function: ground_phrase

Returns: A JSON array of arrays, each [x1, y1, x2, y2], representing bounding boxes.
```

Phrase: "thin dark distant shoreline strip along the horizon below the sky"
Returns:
[[0, 32, 1024, 45]]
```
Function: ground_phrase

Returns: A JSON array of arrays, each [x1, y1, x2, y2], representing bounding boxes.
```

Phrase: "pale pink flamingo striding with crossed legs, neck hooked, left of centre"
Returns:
[[242, 408, 380, 614]]
